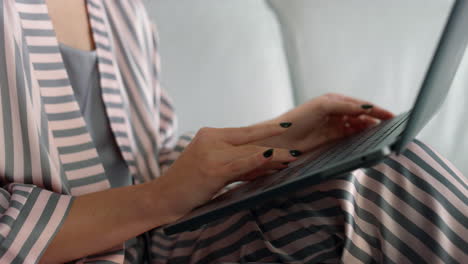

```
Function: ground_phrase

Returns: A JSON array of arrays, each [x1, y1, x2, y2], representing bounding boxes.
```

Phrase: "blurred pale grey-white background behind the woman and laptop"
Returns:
[[145, 0, 468, 175]]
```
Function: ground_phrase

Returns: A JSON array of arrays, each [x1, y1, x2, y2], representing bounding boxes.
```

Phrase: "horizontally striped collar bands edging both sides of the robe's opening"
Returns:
[[15, 0, 136, 195]]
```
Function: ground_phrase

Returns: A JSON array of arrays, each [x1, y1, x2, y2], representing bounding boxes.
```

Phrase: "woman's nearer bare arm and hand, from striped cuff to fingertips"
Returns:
[[41, 124, 296, 263]]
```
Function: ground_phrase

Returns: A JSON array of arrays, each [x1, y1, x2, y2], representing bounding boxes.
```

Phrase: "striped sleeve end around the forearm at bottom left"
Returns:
[[0, 183, 73, 263]]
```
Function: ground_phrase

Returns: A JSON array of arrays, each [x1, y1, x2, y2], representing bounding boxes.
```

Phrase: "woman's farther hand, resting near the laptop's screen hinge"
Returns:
[[257, 94, 394, 154]]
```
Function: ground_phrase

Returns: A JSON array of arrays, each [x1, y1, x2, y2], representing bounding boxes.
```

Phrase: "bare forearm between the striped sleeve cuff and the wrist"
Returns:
[[41, 182, 174, 263]]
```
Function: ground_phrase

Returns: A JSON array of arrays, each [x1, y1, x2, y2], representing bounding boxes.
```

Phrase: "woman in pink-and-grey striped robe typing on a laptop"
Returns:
[[0, 0, 468, 263]]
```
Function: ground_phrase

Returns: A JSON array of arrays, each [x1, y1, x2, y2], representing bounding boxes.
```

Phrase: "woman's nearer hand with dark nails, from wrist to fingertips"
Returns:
[[154, 123, 297, 221]]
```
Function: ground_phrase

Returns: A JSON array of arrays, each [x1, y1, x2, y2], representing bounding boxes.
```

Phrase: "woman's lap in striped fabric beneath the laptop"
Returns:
[[148, 141, 468, 263]]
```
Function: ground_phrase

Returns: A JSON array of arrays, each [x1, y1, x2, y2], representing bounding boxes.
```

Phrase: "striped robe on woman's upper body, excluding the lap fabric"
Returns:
[[0, 0, 189, 263]]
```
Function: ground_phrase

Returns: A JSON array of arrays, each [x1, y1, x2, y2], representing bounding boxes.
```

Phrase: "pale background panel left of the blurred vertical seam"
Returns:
[[146, 0, 293, 132]]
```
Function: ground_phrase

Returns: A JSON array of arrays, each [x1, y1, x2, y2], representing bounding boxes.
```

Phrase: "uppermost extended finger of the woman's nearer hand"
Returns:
[[221, 122, 291, 145]]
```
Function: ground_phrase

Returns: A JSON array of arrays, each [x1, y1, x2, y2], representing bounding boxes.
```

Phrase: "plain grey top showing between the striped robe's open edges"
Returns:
[[59, 44, 132, 187]]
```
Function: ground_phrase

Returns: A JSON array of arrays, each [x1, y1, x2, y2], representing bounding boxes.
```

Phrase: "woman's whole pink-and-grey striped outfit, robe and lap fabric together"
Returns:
[[0, 0, 468, 263]]
